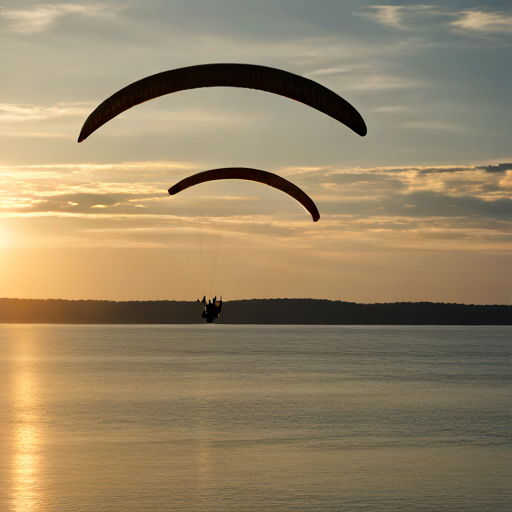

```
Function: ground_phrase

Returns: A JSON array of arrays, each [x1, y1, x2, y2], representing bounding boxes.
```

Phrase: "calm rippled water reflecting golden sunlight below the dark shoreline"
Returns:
[[0, 325, 512, 512]]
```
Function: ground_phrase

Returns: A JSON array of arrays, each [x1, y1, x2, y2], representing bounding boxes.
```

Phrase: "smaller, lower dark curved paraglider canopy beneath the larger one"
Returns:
[[169, 167, 320, 222]]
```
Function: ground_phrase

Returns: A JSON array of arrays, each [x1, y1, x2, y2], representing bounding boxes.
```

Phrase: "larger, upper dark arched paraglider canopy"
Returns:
[[78, 64, 367, 142]]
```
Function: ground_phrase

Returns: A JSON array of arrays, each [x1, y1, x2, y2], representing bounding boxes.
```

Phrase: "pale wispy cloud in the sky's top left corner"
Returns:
[[1, 3, 118, 34]]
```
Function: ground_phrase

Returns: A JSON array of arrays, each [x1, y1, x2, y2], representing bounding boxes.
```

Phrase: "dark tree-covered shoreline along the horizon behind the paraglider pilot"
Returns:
[[0, 299, 512, 325]]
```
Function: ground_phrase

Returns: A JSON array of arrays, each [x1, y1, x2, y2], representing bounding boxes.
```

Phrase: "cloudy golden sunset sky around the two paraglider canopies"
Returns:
[[0, 0, 512, 304]]
